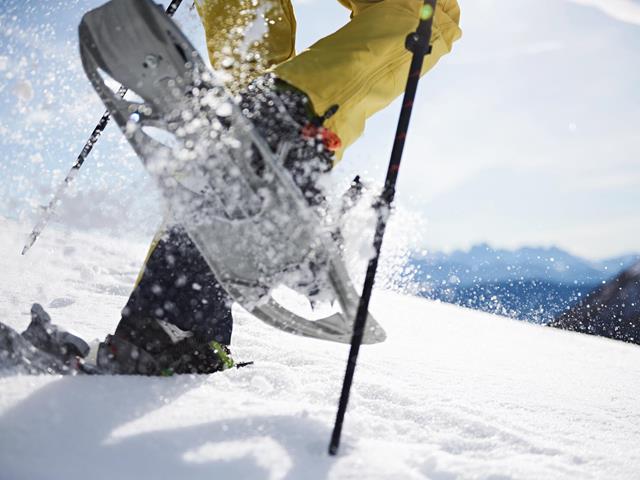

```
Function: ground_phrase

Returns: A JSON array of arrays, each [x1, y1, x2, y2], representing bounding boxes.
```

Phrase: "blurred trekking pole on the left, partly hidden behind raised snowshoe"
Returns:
[[22, 0, 182, 255]]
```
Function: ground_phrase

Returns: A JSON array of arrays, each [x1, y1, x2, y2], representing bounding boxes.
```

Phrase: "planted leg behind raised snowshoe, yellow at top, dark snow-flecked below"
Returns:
[[109, 0, 295, 371]]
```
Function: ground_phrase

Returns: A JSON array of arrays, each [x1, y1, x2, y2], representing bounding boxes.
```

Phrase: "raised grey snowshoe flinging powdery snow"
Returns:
[[80, 0, 385, 344]]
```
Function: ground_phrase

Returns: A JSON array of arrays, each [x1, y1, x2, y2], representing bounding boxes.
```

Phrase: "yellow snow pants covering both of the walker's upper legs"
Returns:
[[196, 0, 462, 160]]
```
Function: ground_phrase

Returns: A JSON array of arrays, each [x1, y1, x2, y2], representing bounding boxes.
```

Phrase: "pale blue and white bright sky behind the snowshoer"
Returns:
[[0, 0, 640, 259]]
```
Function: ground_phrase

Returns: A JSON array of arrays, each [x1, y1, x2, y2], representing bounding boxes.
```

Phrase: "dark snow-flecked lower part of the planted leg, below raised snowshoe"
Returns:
[[102, 226, 233, 375]]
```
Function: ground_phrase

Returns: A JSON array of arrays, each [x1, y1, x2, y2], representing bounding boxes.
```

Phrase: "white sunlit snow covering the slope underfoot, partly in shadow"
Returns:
[[0, 219, 640, 480]]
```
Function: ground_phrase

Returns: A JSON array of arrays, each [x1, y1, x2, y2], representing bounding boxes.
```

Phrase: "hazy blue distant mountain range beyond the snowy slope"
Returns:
[[409, 248, 640, 323]]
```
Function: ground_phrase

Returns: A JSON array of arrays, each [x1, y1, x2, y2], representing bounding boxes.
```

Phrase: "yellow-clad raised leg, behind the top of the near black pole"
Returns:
[[274, 0, 461, 158]]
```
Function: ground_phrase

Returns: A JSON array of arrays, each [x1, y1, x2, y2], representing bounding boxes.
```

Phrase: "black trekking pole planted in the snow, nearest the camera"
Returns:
[[329, 0, 436, 455]]
